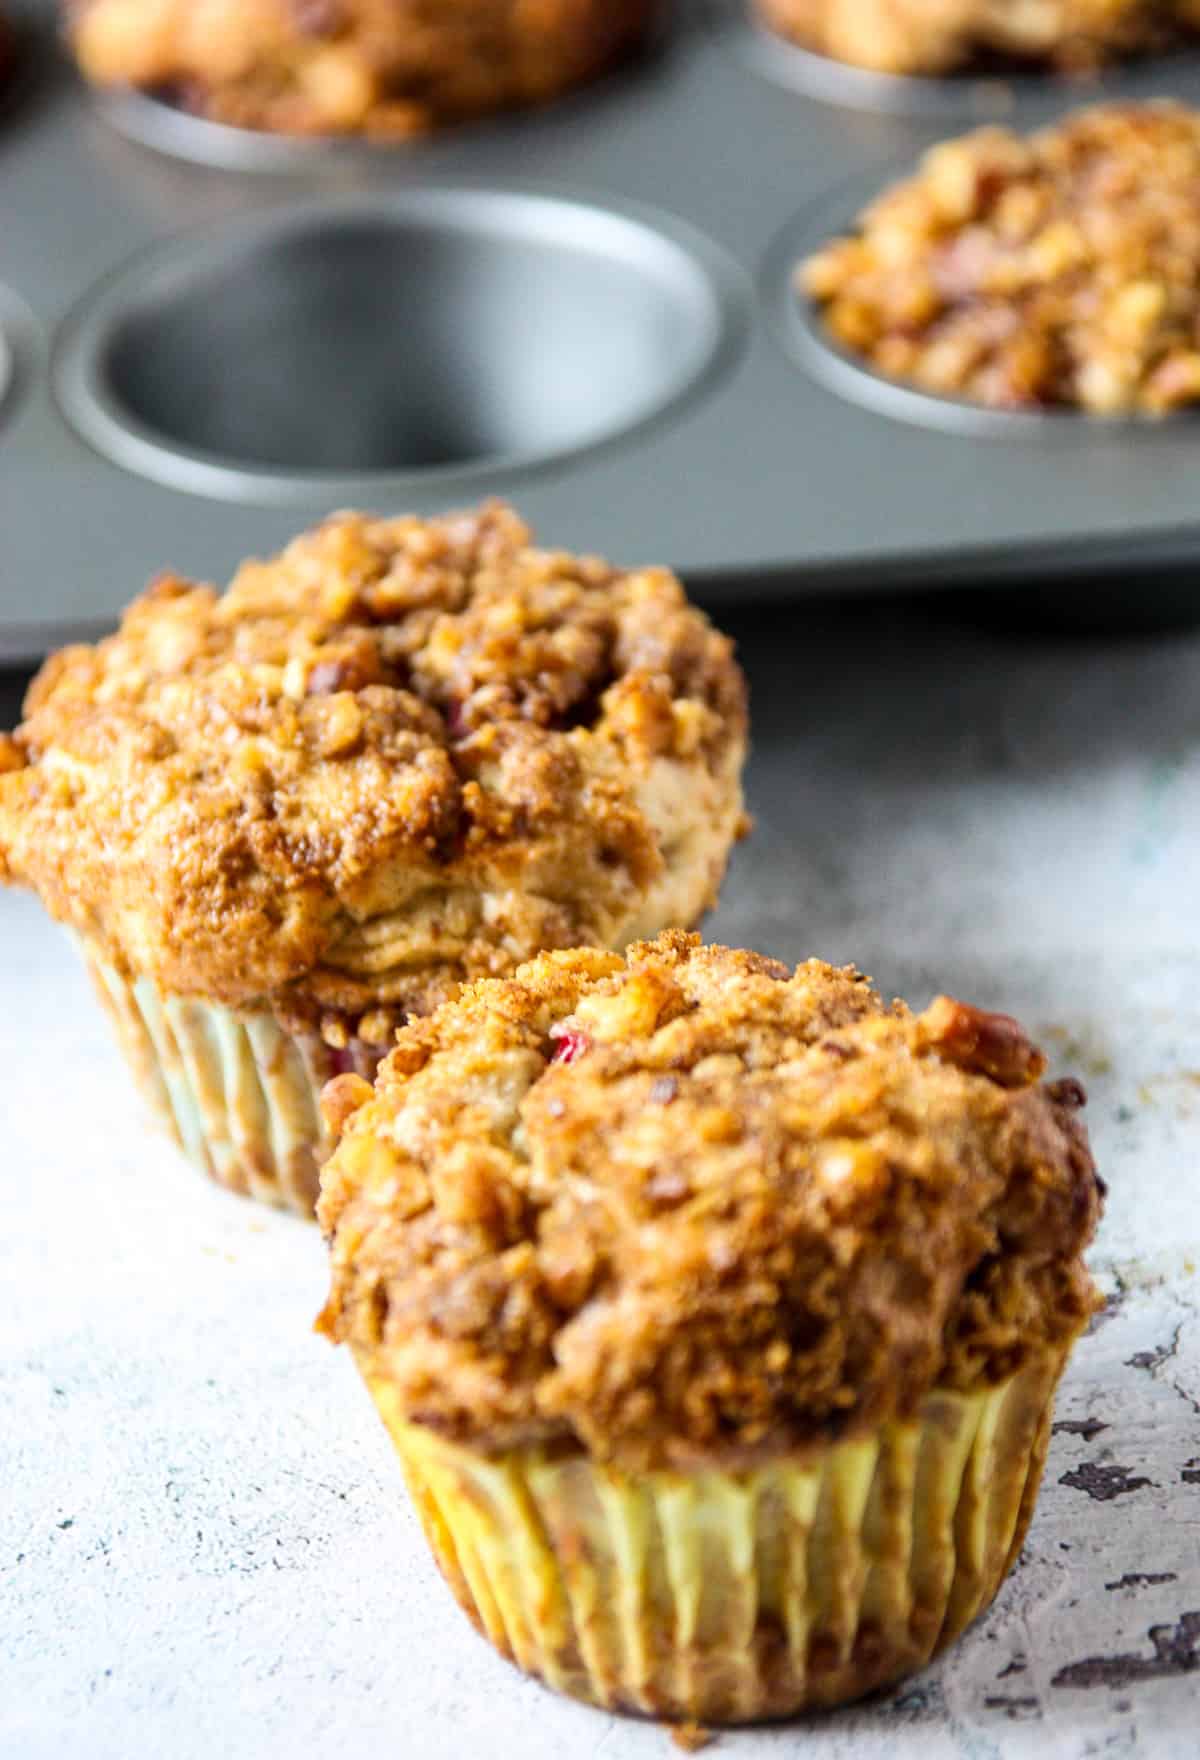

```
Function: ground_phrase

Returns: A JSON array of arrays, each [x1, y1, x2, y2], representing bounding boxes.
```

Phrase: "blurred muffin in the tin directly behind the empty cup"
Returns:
[[69, 0, 655, 139]]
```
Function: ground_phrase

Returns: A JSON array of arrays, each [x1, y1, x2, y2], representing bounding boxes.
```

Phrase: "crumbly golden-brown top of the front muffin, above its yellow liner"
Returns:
[[318, 931, 1101, 1468]]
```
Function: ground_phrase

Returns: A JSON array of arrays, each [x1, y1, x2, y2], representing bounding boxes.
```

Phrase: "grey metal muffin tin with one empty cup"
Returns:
[[0, 0, 1200, 660]]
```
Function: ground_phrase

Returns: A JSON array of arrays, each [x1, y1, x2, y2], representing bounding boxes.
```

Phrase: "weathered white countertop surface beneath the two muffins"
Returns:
[[0, 605, 1200, 1760]]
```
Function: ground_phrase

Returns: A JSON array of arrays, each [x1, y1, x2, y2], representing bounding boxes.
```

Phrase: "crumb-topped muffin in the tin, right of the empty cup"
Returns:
[[799, 102, 1200, 415]]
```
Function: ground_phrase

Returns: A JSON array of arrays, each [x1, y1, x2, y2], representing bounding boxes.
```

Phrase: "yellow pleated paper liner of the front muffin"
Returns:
[[366, 1352, 1065, 1723]]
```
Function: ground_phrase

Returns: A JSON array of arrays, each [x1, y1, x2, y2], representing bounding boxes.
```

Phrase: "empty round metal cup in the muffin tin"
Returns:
[[58, 188, 730, 502]]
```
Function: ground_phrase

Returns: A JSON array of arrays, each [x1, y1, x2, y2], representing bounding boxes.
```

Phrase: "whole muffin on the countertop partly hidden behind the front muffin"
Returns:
[[0, 505, 746, 1213]]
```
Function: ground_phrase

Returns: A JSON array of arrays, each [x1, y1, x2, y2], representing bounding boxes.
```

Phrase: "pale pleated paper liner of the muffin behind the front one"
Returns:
[[83, 949, 373, 1216]]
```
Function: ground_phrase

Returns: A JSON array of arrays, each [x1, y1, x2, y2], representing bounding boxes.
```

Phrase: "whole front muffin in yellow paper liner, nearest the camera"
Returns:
[[318, 931, 1101, 1723]]
